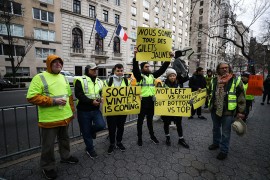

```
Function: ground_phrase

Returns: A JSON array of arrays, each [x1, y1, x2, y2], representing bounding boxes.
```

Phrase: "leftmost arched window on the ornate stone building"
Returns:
[[72, 28, 83, 53]]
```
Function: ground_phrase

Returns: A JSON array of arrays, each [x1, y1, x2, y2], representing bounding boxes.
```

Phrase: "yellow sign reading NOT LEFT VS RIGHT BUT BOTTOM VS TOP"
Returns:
[[155, 88, 192, 117]]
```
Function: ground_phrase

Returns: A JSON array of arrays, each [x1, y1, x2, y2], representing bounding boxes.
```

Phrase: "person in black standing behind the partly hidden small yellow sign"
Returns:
[[188, 67, 206, 120]]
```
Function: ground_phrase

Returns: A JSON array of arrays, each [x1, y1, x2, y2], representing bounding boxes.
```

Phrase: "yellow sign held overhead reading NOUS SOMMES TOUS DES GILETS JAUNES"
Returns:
[[136, 27, 172, 61]]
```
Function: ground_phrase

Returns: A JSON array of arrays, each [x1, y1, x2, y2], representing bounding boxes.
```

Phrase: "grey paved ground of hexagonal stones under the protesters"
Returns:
[[0, 99, 270, 180]]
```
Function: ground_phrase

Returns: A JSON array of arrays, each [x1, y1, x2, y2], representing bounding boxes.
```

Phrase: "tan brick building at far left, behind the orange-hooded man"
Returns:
[[0, 0, 62, 77]]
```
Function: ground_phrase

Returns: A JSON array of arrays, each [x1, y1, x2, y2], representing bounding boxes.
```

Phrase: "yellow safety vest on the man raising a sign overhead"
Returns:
[[138, 74, 155, 97]]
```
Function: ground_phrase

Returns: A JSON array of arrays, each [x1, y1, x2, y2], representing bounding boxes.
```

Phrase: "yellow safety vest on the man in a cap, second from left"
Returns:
[[74, 75, 103, 103]]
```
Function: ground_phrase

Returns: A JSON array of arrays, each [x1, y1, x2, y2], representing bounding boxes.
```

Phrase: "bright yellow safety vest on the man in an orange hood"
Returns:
[[27, 72, 73, 123]]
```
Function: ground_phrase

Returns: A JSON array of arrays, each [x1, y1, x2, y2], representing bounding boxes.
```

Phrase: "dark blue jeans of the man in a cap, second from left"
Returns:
[[78, 110, 106, 152]]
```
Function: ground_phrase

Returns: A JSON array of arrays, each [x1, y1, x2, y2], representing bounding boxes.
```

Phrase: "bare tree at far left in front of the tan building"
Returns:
[[0, 0, 34, 77]]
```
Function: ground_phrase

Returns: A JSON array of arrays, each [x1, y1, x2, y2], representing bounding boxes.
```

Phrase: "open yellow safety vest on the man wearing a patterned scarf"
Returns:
[[209, 77, 241, 111]]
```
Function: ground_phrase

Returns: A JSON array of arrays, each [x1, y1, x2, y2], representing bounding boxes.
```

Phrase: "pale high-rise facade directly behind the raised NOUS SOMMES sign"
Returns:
[[127, 0, 190, 69]]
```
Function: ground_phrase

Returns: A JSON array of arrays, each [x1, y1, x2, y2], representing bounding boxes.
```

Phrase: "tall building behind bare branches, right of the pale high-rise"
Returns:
[[189, 0, 221, 72]]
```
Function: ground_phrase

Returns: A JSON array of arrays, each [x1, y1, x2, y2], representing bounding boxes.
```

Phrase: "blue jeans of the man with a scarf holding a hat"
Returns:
[[211, 111, 233, 154]]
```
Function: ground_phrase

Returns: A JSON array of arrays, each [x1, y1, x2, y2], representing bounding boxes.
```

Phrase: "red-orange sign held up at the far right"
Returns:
[[246, 75, 263, 96]]
